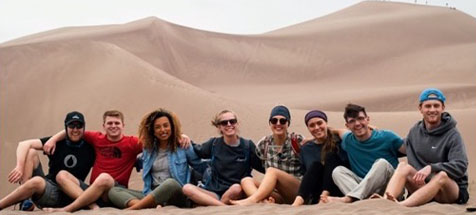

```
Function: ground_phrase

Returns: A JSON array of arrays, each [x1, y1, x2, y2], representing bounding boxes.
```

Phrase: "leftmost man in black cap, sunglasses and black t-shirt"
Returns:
[[0, 111, 95, 210]]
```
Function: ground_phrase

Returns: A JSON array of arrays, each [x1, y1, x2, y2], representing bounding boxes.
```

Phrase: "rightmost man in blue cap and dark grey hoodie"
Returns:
[[384, 88, 469, 206]]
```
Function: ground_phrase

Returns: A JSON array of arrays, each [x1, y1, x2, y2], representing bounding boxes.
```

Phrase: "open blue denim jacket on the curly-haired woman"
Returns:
[[141, 146, 207, 195]]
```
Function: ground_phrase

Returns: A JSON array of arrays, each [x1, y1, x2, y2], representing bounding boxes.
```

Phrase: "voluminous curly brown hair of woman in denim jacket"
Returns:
[[139, 108, 182, 152]]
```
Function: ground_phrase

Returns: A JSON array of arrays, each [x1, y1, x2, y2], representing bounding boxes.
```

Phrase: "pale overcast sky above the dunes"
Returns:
[[0, 0, 476, 43]]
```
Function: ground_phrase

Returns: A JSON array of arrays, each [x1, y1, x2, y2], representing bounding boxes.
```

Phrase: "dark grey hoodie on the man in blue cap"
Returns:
[[405, 112, 468, 188]]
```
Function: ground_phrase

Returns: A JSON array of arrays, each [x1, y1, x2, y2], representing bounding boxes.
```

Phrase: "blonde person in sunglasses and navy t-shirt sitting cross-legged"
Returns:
[[183, 110, 263, 205]]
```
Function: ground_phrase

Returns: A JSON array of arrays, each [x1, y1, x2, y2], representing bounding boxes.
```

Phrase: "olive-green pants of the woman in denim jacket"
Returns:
[[108, 178, 186, 209]]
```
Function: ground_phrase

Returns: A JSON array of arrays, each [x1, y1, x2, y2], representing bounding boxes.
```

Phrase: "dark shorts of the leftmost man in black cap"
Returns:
[[32, 177, 88, 208]]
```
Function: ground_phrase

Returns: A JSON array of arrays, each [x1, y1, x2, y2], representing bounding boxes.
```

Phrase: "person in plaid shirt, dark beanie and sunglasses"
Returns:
[[231, 105, 303, 205]]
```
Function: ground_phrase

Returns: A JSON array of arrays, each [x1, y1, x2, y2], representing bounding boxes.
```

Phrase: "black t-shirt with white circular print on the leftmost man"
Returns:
[[40, 137, 95, 182]]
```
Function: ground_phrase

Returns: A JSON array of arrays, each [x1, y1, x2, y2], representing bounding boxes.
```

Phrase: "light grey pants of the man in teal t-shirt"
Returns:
[[332, 158, 395, 200]]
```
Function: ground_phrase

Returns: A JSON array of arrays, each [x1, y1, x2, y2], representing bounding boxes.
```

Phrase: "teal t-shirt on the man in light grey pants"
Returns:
[[342, 130, 403, 178]]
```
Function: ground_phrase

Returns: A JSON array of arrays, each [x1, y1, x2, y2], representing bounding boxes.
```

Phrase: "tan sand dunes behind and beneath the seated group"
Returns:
[[0, 2, 476, 214]]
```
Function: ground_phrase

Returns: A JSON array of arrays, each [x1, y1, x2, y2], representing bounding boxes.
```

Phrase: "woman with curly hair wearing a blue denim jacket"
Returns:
[[108, 109, 207, 209]]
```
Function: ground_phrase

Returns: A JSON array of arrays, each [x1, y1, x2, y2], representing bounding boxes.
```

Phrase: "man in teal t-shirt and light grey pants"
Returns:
[[321, 104, 405, 203]]
